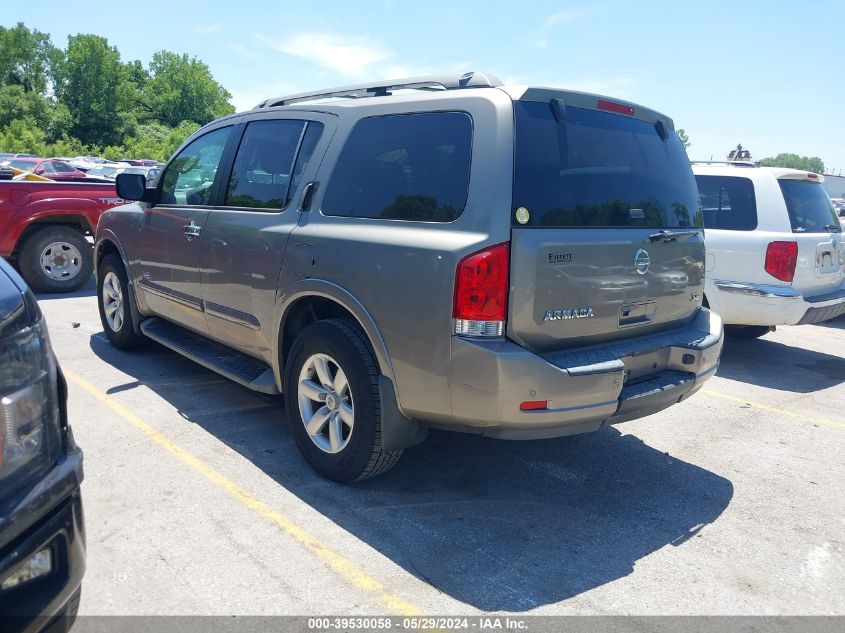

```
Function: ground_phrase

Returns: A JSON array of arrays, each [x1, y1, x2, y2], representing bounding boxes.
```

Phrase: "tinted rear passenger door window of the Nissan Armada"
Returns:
[[224, 119, 314, 210]]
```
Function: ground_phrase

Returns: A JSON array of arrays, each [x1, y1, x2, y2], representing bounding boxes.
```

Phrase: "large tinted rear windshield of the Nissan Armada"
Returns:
[[511, 101, 702, 228]]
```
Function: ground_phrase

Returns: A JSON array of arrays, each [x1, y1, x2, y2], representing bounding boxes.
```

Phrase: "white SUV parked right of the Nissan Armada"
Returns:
[[693, 163, 845, 337]]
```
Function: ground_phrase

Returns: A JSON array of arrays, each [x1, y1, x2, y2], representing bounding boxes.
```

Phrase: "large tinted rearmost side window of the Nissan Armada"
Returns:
[[322, 112, 472, 222]]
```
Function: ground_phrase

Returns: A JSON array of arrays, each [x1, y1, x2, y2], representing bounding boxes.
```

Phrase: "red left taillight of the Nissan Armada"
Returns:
[[452, 242, 510, 336]]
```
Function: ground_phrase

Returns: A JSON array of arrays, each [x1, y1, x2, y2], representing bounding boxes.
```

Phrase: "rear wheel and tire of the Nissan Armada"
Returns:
[[285, 319, 402, 483]]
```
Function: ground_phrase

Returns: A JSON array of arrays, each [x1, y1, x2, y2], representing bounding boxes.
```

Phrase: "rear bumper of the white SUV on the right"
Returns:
[[709, 280, 845, 325]]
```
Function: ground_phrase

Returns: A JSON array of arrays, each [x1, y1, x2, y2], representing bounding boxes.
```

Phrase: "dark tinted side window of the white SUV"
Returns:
[[695, 176, 757, 231]]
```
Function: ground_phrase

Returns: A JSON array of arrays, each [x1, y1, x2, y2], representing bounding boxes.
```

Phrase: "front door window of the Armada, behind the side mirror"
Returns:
[[160, 127, 232, 206]]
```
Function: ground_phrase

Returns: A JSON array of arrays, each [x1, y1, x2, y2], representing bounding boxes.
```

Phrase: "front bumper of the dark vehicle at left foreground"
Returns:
[[0, 449, 85, 633]]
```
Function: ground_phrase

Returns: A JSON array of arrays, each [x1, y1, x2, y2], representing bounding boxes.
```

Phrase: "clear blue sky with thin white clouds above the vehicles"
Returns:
[[6, 0, 845, 173]]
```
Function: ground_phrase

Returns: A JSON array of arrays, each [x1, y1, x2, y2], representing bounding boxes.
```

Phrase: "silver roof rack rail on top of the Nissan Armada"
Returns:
[[255, 72, 503, 109]]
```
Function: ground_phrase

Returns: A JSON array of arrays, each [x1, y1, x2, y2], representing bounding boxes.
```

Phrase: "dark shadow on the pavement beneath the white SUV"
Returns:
[[716, 324, 845, 393]]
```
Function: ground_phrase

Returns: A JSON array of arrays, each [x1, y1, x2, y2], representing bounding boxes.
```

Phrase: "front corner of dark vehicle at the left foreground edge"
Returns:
[[0, 260, 85, 633]]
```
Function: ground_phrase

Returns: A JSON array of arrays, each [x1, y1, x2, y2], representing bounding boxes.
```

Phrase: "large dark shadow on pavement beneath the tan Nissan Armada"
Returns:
[[91, 333, 733, 612]]
